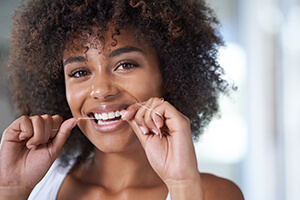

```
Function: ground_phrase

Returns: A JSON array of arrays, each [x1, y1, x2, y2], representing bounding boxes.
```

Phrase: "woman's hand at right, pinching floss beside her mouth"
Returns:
[[122, 98, 201, 192]]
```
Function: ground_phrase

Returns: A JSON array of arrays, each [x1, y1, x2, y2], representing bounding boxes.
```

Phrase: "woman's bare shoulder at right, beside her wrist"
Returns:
[[201, 173, 244, 200]]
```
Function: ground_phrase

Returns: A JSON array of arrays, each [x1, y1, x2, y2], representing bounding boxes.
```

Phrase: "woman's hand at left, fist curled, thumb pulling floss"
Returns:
[[0, 115, 76, 199]]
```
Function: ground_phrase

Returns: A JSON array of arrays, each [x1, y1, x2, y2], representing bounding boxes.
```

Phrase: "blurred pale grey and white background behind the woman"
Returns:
[[0, 0, 300, 200]]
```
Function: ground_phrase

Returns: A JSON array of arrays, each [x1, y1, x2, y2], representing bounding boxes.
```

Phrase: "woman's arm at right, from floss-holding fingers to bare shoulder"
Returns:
[[122, 98, 243, 200]]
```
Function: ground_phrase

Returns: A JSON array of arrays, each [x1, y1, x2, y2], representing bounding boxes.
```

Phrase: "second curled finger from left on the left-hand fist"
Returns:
[[26, 115, 45, 149]]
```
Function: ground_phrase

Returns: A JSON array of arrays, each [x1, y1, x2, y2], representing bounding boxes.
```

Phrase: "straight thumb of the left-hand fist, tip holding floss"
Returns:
[[49, 118, 77, 159]]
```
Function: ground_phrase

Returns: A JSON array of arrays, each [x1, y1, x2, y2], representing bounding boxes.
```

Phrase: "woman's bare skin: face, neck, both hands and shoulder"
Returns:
[[0, 29, 243, 200]]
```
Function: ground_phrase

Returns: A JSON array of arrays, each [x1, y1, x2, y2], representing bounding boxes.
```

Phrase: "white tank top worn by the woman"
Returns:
[[28, 160, 171, 200]]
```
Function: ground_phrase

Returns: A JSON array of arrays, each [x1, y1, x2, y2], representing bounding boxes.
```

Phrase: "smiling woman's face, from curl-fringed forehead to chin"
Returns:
[[63, 29, 163, 152]]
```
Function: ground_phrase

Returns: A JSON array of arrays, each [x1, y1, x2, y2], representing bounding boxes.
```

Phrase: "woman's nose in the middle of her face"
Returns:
[[90, 73, 119, 101]]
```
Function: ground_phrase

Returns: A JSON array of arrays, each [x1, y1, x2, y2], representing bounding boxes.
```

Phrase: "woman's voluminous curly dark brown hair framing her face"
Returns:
[[9, 0, 229, 166]]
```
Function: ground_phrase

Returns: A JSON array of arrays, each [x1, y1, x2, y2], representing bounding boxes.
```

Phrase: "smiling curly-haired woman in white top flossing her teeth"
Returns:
[[0, 0, 243, 200]]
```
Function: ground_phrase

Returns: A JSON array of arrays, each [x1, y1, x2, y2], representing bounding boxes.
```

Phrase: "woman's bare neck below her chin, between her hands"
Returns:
[[79, 141, 163, 192]]
